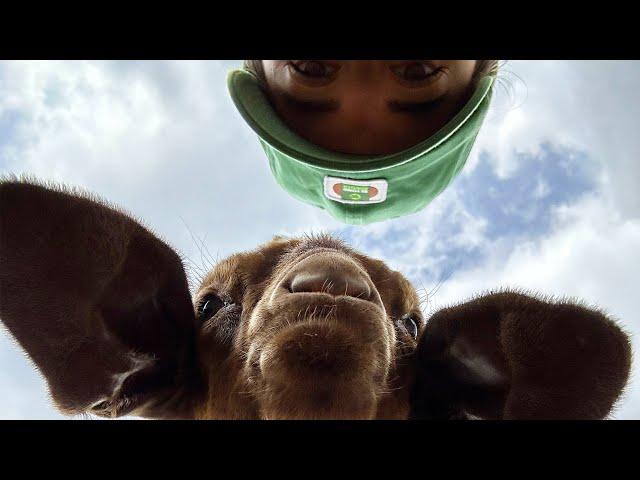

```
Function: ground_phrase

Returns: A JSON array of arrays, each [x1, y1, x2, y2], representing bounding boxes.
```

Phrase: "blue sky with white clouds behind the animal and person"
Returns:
[[0, 60, 640, 419]]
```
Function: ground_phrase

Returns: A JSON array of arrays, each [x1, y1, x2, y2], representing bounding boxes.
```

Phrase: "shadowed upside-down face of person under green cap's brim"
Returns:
[[262, 60, 476, 155]]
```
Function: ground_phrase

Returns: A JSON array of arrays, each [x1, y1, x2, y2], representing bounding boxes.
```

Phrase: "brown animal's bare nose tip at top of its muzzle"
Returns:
[[290, 268, 371, 300]]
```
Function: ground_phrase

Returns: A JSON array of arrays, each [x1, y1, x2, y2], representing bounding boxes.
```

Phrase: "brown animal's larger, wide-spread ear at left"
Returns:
[[0, 180, 199, 418]]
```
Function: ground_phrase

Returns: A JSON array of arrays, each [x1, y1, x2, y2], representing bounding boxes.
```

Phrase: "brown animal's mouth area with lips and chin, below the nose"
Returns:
[[247, 294, 394, 418]]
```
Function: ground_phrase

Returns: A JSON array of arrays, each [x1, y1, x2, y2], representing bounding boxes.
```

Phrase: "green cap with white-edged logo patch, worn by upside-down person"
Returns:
[[227, 69, 494, 225]]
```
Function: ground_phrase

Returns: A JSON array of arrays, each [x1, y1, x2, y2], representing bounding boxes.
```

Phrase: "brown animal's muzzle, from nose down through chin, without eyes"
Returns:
[[248, 250, 395, 418]]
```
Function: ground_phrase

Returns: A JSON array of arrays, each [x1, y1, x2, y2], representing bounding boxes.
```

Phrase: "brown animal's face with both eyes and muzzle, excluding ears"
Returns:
[[194, 236, 423, 418]]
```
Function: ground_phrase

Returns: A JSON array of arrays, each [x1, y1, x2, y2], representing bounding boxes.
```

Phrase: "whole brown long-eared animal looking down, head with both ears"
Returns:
[[0, 178, 631, 419]]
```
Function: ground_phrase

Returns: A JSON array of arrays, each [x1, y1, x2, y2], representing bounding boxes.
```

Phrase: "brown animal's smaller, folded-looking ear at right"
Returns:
[[411, 292, 631, 419]]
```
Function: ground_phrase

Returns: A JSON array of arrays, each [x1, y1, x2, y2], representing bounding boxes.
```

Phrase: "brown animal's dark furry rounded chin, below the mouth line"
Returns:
[[259, 322, 388, 419]]
